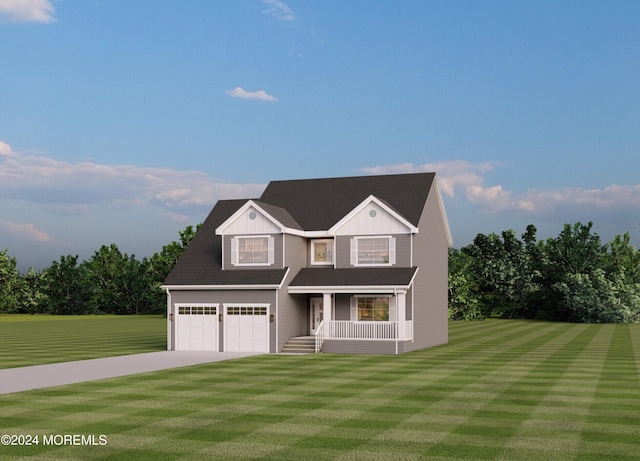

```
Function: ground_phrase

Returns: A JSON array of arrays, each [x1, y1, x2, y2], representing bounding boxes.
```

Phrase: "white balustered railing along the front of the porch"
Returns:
[[324, 320, 413, 341]]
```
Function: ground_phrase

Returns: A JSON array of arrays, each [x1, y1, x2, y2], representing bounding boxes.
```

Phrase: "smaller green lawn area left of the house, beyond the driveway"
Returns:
[[0, 314, 167, 368]]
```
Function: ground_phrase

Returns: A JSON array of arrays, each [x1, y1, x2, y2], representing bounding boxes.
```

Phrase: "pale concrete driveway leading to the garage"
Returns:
[[0, 351, 258, 394]]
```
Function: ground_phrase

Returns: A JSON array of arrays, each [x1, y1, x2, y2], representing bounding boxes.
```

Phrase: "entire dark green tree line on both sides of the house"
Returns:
[[0, 222, 640, 323]]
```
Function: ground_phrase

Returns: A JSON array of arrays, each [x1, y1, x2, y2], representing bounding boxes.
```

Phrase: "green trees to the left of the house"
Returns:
[[0, 225, 200, 315]]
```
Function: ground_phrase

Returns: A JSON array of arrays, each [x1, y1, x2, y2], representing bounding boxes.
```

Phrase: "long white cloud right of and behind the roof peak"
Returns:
[[361, 160, 640, 215]]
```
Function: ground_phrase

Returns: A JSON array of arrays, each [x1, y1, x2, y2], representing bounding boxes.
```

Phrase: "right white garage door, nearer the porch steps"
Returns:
[[224, 306, 269, 352]]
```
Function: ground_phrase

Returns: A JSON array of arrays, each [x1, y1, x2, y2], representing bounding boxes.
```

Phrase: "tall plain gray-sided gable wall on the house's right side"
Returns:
[[404, 183, 449, 351]]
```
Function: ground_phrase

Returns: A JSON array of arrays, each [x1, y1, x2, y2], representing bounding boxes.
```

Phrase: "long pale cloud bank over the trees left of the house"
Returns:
[[0, 141, 265, 219]]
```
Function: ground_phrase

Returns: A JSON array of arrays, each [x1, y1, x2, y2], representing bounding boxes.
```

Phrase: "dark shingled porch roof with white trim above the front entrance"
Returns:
[[288, 267, 418, 293]]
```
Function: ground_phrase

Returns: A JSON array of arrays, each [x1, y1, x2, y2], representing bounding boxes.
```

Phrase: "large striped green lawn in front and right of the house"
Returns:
[[0, 320, 640, 461]]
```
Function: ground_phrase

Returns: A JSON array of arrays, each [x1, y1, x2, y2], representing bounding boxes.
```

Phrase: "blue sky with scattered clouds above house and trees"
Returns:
[[0, 0, 640, 270]]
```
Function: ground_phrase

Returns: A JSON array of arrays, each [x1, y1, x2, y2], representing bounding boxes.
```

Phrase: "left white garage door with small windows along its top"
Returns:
[[176, 305, 218, 351]]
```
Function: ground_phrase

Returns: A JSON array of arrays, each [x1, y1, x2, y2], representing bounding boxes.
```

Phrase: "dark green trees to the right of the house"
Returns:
[[449, 222, 640, 323]]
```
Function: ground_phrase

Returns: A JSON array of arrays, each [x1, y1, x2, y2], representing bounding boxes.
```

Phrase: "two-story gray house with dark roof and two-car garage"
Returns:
[[163, 173, 451, 354]]
